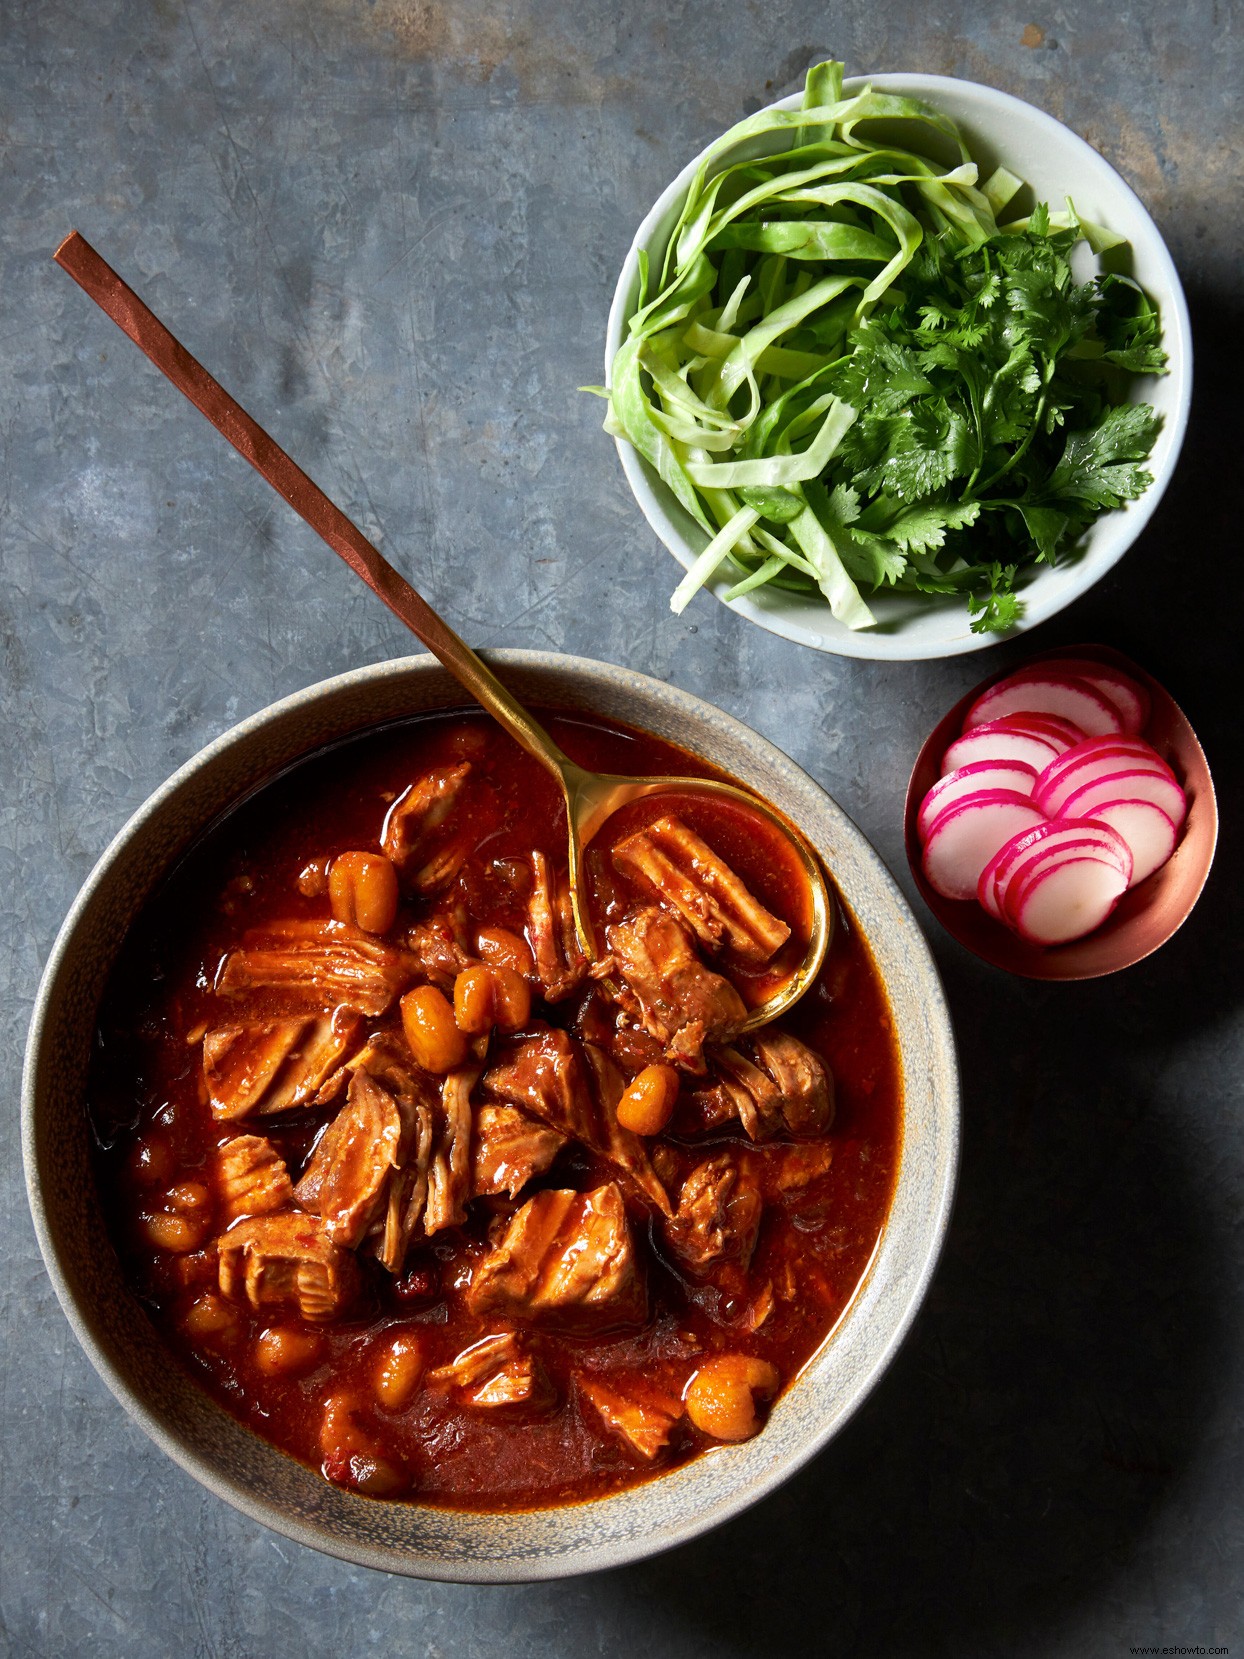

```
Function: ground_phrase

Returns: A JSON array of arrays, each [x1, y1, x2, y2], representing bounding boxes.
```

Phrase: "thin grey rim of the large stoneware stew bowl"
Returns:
[[22, 650, 962, 1583]]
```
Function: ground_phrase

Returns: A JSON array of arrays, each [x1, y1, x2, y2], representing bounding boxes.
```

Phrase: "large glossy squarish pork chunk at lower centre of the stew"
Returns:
[[466, 1183, 647, 1329]]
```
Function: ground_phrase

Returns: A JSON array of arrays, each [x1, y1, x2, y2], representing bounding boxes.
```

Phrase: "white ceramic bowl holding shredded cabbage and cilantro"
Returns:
[[605, 75, 1193, 660]]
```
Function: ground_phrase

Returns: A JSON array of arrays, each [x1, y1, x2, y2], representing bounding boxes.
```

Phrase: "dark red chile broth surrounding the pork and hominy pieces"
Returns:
[[90, 712, 901, 1510]]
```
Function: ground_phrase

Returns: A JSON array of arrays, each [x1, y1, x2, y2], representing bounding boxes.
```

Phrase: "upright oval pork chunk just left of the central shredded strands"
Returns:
[[294, 1068, 403, 1248]]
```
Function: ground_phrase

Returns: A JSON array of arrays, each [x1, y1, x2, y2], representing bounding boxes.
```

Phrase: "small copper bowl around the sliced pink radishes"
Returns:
[[904, 645, 1217, 979]]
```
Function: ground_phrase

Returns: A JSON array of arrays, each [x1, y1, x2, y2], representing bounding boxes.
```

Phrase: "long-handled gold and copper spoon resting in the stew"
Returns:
[[55, 231, 833, 1030]]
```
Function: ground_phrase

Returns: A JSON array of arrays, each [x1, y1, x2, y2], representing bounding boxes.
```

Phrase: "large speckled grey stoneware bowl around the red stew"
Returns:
[[23, 650, 959, 1583]]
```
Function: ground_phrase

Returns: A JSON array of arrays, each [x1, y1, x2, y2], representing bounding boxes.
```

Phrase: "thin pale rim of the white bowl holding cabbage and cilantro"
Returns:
[[605, 71, 1193, 662]]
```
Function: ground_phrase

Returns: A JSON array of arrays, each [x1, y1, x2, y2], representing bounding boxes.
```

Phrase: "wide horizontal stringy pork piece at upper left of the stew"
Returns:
[[216, 921, 420, 1015]]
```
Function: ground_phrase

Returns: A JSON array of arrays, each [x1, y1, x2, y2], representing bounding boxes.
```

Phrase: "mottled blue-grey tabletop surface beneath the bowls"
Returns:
[[0, 0, 1244, 1659]]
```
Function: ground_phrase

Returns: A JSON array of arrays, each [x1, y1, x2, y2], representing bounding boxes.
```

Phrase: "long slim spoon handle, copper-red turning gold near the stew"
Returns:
[[53, 231, 571, 776]]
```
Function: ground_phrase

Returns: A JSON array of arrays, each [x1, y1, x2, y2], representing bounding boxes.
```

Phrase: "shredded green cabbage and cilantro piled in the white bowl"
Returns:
[[605, 63, 1166, 632]]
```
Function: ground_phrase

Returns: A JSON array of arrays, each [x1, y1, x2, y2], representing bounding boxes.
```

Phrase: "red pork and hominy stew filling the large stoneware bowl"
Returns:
[[90, 713, 901, 1510]]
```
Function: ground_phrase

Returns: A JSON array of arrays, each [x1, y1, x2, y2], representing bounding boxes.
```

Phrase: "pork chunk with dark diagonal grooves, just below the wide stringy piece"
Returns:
[[202, 1009, 360, 1120]]
